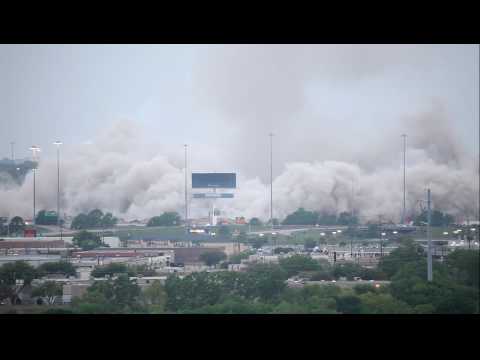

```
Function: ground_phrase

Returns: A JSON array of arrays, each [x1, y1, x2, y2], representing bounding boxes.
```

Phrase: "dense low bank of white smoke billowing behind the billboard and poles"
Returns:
[[0, 118, 478, 221]]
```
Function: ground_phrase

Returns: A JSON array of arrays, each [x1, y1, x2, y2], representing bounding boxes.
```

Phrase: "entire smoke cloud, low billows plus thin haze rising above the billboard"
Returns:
[[0, 45, 479, 221]]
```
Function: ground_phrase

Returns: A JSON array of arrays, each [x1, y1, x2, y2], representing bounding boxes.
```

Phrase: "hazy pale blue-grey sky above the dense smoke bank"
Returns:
[[0, 45, 478, 176]]
